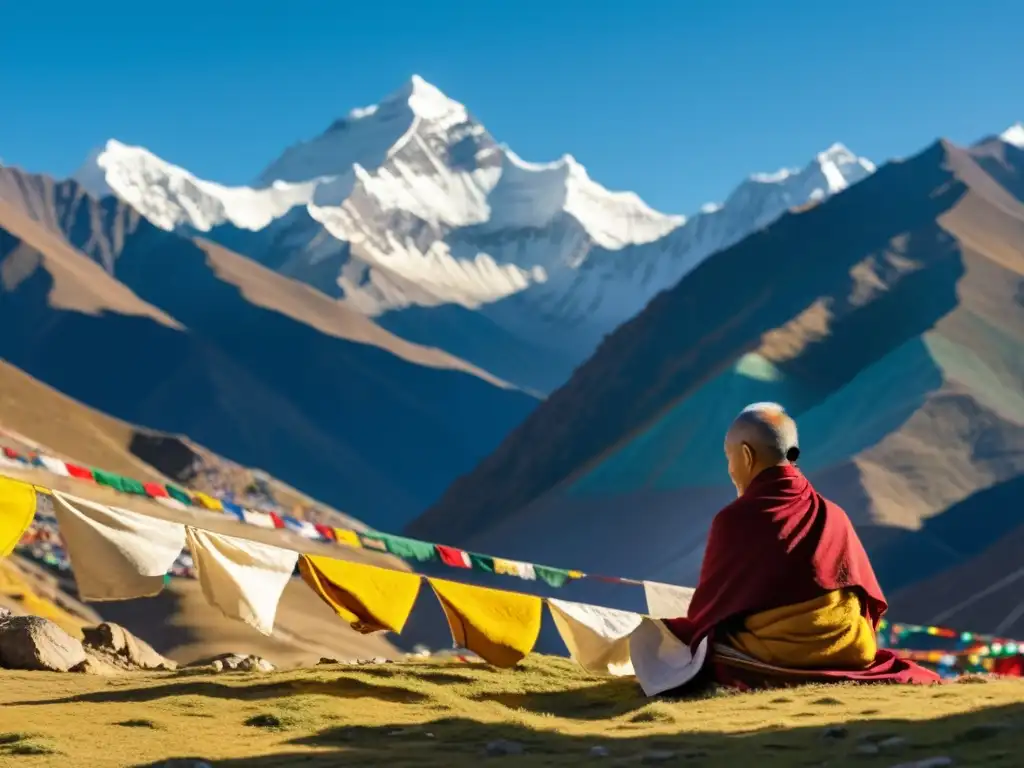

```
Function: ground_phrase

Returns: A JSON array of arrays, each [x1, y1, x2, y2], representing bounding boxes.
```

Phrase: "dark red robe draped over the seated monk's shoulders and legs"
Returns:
[[666, 466, 939, 683]]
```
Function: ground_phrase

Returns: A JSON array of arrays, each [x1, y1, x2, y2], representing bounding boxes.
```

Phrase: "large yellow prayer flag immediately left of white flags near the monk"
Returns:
[[427, 577, 542, 667]]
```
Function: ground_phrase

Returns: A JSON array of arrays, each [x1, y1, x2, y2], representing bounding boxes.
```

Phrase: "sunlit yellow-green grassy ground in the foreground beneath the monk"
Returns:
[[0, 656, 1024, 768]]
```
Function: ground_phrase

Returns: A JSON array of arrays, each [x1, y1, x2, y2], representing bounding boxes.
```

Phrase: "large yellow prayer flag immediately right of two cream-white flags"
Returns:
[[299, 555, 422, 635]]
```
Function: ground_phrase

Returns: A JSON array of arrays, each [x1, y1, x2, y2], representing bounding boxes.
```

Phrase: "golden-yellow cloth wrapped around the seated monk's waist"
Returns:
[[729, 590, 878, 670]]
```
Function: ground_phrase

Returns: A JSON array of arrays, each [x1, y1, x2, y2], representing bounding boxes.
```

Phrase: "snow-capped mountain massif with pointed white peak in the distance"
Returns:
[[76, 77, 874, 392]]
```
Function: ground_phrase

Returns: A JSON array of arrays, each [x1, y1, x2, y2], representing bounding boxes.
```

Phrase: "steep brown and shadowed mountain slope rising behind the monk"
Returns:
[[408, 133, 1024, 636]]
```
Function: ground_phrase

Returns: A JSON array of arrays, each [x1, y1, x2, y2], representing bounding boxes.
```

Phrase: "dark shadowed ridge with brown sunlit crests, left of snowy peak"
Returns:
[[0, 168, 537, 528]]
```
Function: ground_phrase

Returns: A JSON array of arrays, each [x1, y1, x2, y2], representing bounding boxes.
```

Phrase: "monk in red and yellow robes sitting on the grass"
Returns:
[[666, 403, 939, 688]]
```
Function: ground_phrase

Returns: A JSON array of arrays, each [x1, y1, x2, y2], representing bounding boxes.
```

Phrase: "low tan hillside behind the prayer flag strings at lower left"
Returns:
[[0, 360, 401, 664]]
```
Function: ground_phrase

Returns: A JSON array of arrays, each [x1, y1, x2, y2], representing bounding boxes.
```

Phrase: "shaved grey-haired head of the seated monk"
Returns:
[[725, 402, 800, 494]]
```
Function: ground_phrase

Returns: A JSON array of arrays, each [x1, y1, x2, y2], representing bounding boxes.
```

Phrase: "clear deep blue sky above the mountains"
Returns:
[[0, 0, 1024, 213]]
